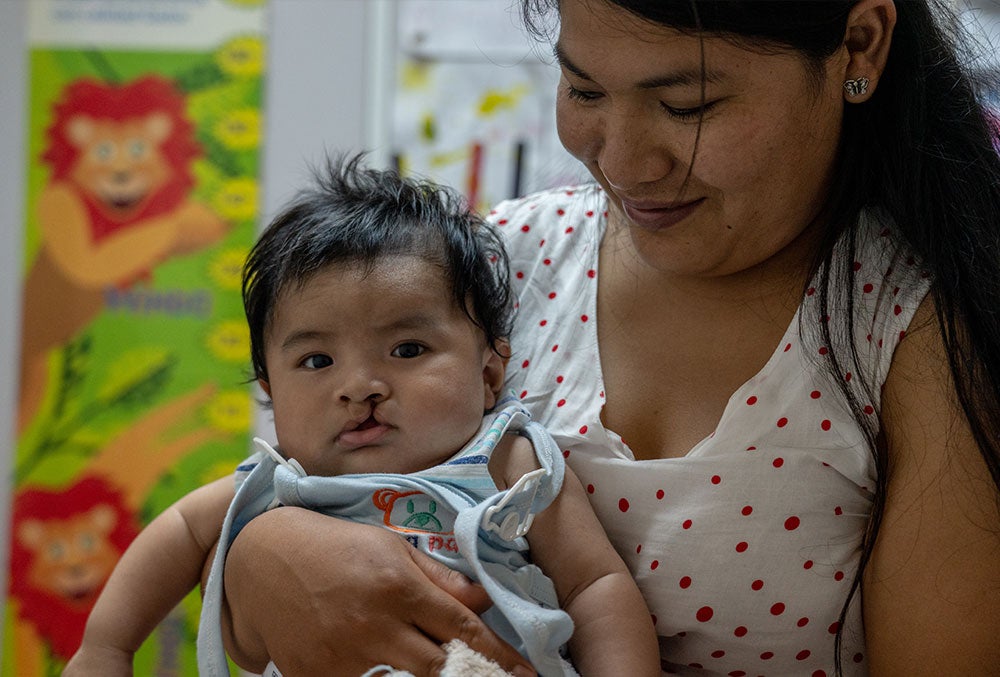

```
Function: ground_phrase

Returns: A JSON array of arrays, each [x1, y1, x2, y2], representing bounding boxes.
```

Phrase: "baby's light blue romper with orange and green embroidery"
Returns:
[[198, 397, 576, 677]]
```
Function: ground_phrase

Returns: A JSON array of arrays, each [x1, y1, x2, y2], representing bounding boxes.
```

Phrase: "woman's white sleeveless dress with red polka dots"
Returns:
[[489, 186, 929, 677]]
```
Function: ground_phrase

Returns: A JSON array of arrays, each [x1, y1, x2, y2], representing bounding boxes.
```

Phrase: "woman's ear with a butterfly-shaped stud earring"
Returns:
[[844, 0, 896, 103]]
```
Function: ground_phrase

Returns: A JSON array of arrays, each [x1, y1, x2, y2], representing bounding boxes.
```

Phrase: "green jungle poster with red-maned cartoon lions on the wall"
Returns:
[[0, 0, 266, 677]]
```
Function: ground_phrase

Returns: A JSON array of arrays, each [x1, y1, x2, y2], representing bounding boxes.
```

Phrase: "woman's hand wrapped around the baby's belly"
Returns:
[[223, 508, 535, 677]]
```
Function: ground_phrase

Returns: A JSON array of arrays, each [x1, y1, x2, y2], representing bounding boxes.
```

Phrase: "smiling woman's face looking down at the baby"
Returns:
[[556, 0, 847, 277]]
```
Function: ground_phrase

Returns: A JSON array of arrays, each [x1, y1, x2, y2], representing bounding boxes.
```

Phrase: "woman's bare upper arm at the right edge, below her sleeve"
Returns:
[[863, 301, 1000, 675]]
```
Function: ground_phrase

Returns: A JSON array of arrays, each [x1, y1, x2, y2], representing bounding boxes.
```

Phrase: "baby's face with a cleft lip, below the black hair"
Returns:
[[262, 256, 503, 475]]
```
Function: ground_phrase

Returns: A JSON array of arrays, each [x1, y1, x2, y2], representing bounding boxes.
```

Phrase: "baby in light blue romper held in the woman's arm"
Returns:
[[60, 157, 660, 676]]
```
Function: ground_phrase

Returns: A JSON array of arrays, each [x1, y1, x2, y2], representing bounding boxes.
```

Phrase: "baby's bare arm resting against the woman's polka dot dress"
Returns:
[[490, 436, 660, 677]]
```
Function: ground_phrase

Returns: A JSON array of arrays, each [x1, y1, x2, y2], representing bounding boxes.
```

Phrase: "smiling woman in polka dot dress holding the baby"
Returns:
[[219, 0, 1000, 675]]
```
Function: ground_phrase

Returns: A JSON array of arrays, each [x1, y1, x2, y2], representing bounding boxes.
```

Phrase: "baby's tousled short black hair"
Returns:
[[243, 154, 513, 380]]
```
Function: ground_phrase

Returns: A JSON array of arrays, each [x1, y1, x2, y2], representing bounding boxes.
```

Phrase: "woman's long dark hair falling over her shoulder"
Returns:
[[521, 0, 1000, 674]]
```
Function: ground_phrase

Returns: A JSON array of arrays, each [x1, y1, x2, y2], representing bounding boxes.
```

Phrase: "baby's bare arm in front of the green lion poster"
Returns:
[[63, 477, 233, 677]]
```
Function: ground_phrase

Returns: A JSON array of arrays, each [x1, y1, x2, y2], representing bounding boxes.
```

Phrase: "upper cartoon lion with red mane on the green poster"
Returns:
[[18, 75, 227, 430]]
